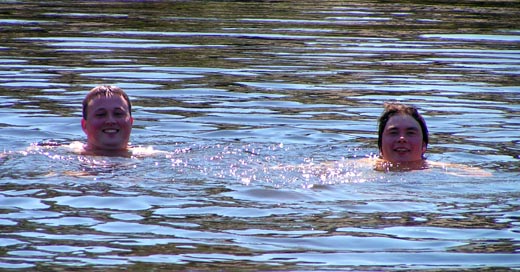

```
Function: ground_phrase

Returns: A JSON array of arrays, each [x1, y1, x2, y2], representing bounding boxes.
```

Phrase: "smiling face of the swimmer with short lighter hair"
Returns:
[[81, 95, 134, 150]]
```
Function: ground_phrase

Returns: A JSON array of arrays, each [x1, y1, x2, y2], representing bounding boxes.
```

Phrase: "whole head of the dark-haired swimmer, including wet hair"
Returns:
[[377, 103, 428, 162]]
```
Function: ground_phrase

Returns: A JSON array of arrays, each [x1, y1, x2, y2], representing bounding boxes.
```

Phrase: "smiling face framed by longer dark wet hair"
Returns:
[[380, 114, 426, 163]]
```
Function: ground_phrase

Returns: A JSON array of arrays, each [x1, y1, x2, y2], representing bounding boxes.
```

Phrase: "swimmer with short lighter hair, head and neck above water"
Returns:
[[77, 86, 134, 156]]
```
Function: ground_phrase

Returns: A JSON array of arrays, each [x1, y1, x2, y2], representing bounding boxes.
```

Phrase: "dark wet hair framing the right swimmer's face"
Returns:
[[377, 103, 428, 150]]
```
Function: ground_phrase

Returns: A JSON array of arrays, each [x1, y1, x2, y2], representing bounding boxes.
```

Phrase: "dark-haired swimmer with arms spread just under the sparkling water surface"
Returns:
[[273, 103, 491, 178]]
